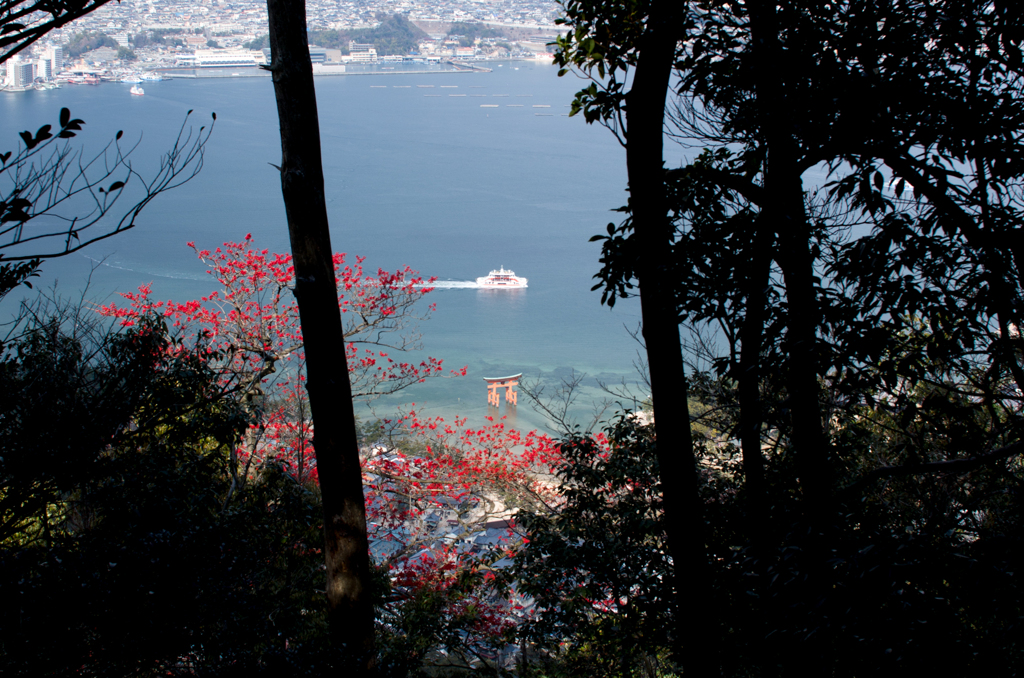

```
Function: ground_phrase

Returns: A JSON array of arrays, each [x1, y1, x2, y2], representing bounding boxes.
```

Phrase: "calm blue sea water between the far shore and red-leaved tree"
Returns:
[[0, 62, 651, 436]]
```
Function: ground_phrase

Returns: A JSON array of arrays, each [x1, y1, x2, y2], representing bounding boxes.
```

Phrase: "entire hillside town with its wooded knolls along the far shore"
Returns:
[[0, 0, 558, 92]]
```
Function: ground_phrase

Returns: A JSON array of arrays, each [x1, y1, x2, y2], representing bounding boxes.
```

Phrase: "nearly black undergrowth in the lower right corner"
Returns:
[[720, 395, 1024, 676]]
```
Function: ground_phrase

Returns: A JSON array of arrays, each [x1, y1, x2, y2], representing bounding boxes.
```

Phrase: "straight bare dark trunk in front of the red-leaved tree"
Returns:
[[267, 0, 374, 670]]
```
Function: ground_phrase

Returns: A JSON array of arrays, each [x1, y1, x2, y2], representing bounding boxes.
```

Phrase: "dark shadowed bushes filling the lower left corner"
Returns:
[[0, 315, 325, 676]]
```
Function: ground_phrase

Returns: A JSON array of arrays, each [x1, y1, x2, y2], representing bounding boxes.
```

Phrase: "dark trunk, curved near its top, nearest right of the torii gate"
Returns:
[[626, 0, 719, 676]]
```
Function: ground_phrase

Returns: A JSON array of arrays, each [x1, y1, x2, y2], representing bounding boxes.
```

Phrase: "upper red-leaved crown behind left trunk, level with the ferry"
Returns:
[[100, 235, 452, 398]]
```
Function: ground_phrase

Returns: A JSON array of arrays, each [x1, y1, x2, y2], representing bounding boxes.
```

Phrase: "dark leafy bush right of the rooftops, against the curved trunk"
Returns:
[[508, 418, 673, 676]]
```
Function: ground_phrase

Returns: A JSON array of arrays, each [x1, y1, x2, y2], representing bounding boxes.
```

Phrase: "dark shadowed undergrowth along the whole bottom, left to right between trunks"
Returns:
[[0, 311, 1022, 676]]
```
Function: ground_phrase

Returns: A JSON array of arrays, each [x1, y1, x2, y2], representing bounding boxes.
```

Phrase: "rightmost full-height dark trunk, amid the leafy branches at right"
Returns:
[[750, 2, 836, 675]]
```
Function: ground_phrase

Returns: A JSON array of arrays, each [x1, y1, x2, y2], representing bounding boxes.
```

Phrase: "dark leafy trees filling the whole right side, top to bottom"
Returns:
[[556, 1, 1024, 675]]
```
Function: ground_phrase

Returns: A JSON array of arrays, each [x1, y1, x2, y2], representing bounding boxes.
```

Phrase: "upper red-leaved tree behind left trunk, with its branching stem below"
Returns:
[[99, 235, 465, 497]]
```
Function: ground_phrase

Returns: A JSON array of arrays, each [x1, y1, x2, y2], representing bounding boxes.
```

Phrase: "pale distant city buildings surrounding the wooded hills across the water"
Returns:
[[0, 0, 560, 90]]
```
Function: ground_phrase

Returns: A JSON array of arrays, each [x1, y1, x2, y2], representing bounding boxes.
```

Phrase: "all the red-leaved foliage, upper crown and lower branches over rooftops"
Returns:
[[99, 236, 577, 662]]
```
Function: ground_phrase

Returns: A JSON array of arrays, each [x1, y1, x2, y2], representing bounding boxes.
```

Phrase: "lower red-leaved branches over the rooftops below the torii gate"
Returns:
[[364, 411, 562, 669]]
